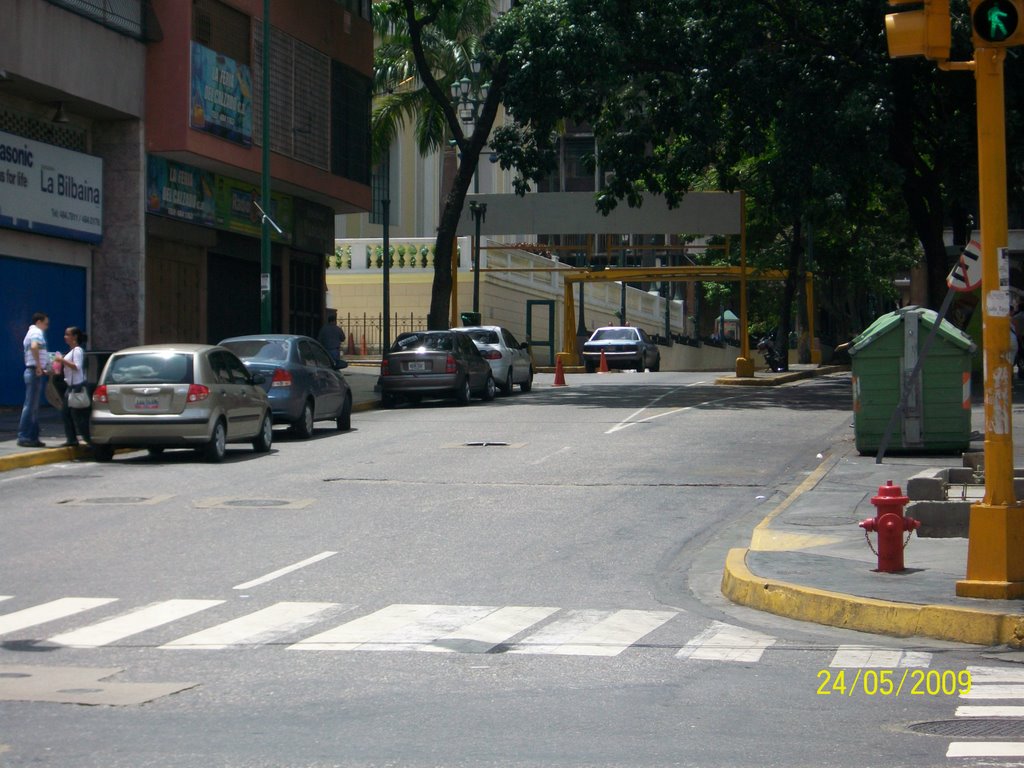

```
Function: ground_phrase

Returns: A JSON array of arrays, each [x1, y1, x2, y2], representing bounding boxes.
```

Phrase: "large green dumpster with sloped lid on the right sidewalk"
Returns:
[[850, 306, 977, 454]]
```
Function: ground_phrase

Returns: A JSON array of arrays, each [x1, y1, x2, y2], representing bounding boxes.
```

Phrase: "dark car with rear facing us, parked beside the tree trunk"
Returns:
[[380, 331, 496, 407]]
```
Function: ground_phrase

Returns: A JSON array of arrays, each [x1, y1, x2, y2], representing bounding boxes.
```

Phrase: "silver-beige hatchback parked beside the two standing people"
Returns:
[[90, 344, 273, 462]]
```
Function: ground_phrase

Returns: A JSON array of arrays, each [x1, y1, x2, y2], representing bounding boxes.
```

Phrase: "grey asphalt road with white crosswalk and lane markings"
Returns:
[[0, 373, 999, 768]]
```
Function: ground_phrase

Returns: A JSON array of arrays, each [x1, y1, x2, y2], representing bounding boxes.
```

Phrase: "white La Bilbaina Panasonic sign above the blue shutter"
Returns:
[[0, 131, 103, 243]]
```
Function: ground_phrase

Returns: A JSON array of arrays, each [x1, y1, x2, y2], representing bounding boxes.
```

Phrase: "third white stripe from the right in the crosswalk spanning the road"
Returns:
[[509, 610, 678, 656]]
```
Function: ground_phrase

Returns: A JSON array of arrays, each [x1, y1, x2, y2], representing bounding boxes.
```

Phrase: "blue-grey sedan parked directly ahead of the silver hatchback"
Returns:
[[220, 334, 352, 437]]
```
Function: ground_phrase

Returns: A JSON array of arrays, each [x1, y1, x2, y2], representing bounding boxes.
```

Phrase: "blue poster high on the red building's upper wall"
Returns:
[[188, 42, 253, 146]]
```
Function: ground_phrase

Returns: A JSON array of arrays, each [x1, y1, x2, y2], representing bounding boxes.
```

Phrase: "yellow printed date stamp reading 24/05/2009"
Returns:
[[817, 669, 971, 697]]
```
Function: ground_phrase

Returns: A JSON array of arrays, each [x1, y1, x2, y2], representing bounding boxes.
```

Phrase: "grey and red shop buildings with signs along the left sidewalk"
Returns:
[[0, 0, 373, 404]]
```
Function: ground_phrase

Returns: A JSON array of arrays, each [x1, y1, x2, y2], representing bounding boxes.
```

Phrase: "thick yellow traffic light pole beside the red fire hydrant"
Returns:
[[956, 48, 1024, 600]]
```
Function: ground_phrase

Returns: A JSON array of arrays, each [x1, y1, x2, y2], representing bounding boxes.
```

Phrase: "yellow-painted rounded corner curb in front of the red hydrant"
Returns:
[[722, 548, 1024, 647]]
